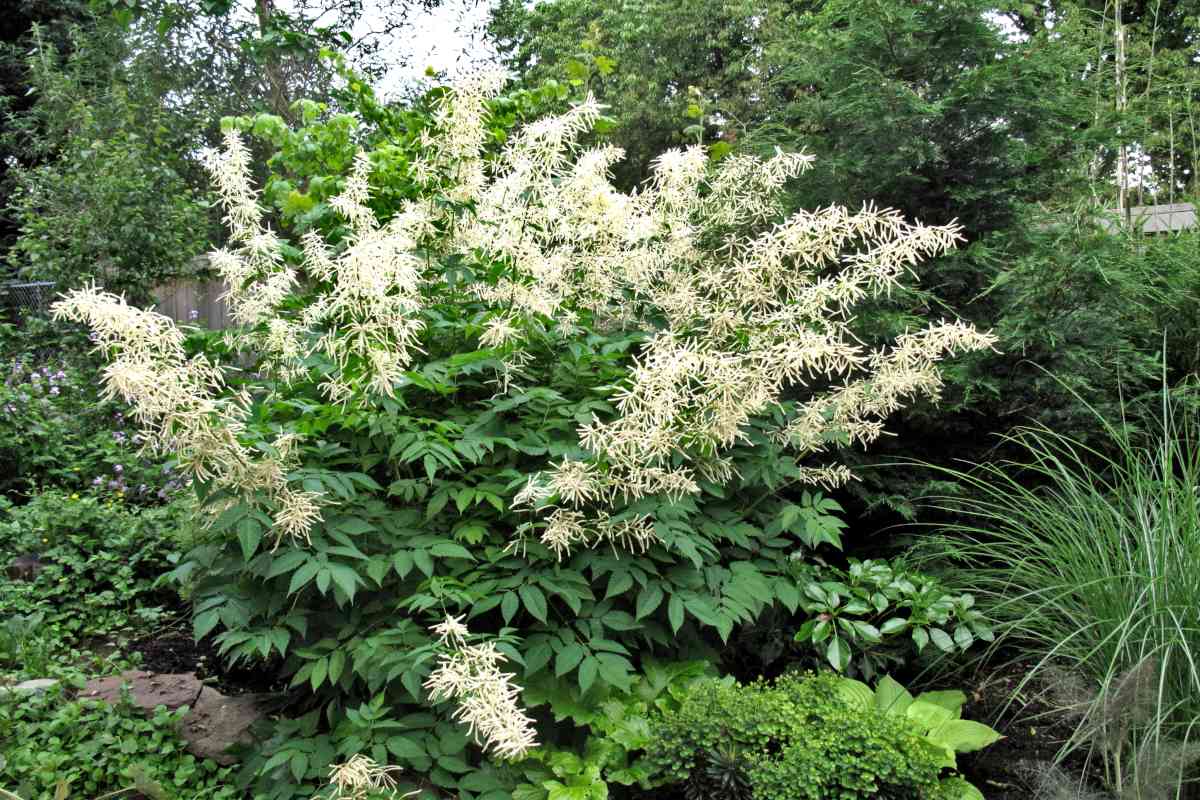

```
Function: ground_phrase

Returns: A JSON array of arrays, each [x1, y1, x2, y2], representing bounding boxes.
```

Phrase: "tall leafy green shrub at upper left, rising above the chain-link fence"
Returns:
[[5, 29, 210, 301]]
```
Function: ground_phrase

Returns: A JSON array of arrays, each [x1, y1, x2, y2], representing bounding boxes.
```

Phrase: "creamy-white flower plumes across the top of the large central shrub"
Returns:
[[58, 73, 995, 551]]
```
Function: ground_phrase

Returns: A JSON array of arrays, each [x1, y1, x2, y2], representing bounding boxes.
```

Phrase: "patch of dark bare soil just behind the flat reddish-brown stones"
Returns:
[[125, 632, 286, 694]]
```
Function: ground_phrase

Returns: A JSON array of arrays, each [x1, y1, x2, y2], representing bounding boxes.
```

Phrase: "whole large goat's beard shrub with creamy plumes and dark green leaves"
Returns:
[[55, 71, 991, 798]]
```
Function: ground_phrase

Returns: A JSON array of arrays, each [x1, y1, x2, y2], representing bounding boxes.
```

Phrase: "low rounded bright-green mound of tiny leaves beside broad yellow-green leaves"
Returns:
[[647, 673, 958, 800]]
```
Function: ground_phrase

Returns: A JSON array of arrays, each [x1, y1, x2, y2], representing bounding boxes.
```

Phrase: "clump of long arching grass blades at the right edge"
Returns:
[[919, 391, 1200, 796]]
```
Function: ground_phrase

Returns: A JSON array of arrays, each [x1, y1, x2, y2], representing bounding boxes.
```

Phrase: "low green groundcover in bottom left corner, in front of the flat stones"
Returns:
[[0, 688, 241, 800]]
